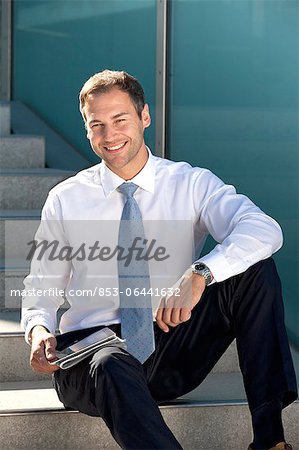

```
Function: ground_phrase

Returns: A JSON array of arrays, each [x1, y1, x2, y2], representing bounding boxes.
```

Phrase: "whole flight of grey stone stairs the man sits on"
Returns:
[[0, 106, 299, 450]]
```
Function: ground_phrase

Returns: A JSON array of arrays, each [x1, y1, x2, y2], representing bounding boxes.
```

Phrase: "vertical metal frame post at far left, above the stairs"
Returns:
[[0, 0, 12, 100]]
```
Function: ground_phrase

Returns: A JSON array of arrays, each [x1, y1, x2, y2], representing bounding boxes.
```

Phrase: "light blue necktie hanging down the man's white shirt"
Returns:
[[118, 183, 155, 363]]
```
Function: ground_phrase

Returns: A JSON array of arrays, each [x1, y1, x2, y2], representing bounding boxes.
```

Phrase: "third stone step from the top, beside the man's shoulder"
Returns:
[[0, 169, 73, 209]]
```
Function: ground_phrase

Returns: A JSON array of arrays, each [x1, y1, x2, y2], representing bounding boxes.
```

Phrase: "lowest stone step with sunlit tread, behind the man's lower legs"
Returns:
[[0, 374, 299, 450]]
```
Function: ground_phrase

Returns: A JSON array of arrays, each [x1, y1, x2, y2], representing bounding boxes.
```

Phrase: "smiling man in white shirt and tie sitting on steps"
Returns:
[[22, 70, 297, 450]]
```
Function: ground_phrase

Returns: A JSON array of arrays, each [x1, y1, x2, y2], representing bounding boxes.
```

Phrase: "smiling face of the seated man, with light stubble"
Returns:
[[85, 88, 150, 179]]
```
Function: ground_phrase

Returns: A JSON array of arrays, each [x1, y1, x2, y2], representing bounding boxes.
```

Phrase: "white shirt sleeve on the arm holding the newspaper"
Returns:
[[21, 193, 71, 343]]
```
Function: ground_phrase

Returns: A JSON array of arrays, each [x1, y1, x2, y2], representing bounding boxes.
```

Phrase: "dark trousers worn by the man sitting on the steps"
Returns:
[[54, 258, 297, 450]]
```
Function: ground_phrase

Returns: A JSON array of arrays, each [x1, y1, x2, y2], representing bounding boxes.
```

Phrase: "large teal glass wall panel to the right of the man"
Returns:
[[168, 0, 299, 344]]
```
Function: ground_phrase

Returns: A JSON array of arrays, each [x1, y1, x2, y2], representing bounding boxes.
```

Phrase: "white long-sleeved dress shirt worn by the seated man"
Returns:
[[22, 151, 282, 341]]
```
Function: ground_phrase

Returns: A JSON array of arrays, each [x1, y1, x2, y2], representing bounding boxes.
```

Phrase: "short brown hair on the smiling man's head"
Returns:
[[79, 69, 145, 121]]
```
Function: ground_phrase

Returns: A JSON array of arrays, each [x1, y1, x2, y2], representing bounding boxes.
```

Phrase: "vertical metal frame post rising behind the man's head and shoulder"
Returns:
[[155, 0, 167, 158]]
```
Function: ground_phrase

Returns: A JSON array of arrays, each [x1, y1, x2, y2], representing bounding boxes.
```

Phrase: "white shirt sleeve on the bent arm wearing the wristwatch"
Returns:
[[194, 170, 283, 282]]
